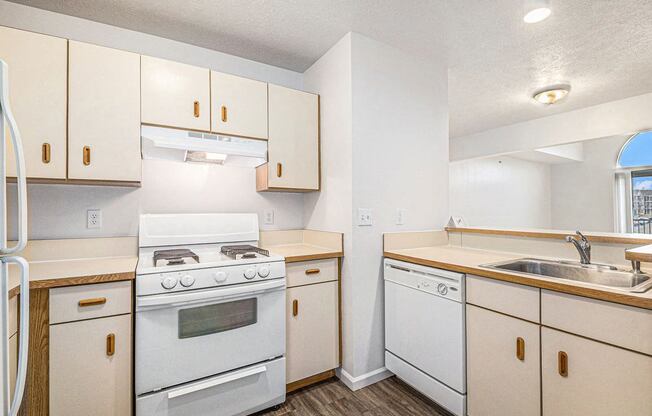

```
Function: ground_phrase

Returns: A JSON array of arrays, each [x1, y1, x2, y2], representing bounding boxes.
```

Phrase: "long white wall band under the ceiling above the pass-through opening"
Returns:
[[450, 93, 652, 161]]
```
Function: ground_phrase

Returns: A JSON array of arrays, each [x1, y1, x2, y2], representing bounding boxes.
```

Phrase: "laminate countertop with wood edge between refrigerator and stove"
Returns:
[[9, 256, 138, 298]]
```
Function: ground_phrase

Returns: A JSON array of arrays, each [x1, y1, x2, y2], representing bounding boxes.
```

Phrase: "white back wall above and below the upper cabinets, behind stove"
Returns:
[[0, 0, 303, 239]]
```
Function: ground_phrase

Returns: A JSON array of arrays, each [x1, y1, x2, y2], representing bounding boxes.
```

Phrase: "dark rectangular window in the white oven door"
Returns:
[[179, 298, 258, 339]]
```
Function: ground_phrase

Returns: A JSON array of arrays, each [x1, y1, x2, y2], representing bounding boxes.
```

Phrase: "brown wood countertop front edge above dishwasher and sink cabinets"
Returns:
[[383, 251, 652, 309]]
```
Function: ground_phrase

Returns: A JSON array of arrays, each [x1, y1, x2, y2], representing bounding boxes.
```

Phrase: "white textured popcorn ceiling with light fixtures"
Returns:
[[8, 0, 652, 137]]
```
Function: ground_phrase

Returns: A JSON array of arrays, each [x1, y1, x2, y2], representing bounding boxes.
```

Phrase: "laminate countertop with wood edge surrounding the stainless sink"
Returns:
[[384, 245, 652, 309]]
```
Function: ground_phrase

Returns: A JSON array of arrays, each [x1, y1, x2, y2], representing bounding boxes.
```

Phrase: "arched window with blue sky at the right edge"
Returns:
[[616, 131, 652, 234]]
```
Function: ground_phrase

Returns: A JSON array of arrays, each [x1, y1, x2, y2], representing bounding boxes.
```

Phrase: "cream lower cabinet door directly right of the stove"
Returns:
[[286, 282, 339, 383]]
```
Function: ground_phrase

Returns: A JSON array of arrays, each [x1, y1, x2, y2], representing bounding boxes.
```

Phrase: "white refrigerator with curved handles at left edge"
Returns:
[[0, 59, 29, 416]]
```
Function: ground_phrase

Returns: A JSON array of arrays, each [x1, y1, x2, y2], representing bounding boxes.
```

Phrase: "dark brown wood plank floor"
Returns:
[[256, 377, 450, 416]]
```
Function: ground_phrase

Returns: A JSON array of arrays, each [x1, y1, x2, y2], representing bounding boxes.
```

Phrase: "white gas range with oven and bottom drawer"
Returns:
[[135, 214, 285, 416]]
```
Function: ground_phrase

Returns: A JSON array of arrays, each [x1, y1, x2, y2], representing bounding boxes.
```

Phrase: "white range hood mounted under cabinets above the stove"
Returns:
[[141, 126, 267, 167]]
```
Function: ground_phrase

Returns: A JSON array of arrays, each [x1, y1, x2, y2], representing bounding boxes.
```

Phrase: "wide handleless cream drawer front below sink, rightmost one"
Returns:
[[541, 290, 652, 355]]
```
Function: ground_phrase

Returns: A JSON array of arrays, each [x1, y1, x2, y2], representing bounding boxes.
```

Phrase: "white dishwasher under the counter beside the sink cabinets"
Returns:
[[384, 259, 466, 416]]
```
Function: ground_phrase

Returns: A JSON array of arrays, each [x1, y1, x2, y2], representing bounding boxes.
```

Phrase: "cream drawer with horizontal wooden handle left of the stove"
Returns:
[[50, 281, 131, 324]]
